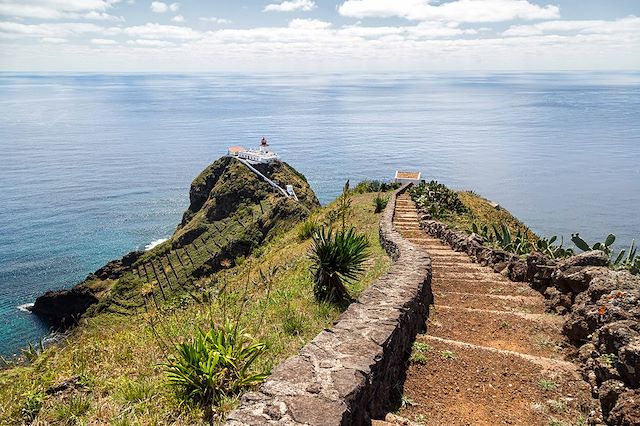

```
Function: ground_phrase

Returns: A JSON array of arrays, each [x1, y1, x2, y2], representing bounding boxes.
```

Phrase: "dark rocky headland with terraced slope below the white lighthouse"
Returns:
[[33, 157, 320, 326]]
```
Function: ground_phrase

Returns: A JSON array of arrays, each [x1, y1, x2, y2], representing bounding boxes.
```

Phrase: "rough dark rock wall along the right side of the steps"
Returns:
[[422, 220, 640, 425]]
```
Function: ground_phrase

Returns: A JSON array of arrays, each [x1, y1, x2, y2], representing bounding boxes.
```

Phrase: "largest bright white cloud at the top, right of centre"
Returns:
[[338, 0, 560, 22]]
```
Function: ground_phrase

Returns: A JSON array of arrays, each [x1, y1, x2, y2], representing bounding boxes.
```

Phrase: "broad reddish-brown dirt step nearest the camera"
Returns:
[[400, 336, 589, 426]]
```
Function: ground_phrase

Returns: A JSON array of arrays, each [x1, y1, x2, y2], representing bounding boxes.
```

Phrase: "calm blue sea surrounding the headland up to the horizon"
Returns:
[[0, 73, 640, 354]]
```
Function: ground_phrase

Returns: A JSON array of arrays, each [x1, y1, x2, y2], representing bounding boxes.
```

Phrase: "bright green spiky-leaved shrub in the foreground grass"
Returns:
[[164, 321, 267, 407]]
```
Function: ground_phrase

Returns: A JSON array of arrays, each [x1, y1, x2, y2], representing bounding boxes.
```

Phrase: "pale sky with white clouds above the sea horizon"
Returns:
[[0, 0, 640, 73]]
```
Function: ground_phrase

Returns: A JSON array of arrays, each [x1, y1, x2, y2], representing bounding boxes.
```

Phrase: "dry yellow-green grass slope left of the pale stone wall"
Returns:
[[0, 193, 391, 425]]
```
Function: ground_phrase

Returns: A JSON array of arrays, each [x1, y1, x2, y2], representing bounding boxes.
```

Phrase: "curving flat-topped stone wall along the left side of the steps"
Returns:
[[227, 186, 433, 426]]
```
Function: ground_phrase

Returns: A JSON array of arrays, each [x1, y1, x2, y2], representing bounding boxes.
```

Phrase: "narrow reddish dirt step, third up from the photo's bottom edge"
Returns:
[[433, 291, 546, 314]]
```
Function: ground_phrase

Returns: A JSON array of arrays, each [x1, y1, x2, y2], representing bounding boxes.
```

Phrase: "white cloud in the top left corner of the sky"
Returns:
[[0, 0, 123, 21]]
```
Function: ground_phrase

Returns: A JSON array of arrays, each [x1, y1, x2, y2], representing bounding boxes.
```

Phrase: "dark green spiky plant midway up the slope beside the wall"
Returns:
[[309, 226, 369, 303]]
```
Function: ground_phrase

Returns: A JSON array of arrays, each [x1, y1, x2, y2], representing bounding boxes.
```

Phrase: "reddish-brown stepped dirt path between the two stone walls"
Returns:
[[384, 194, 591, 426]]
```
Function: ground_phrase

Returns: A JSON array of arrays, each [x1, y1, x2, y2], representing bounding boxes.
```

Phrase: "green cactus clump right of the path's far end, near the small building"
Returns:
[[409, 181, 469, 218]]
